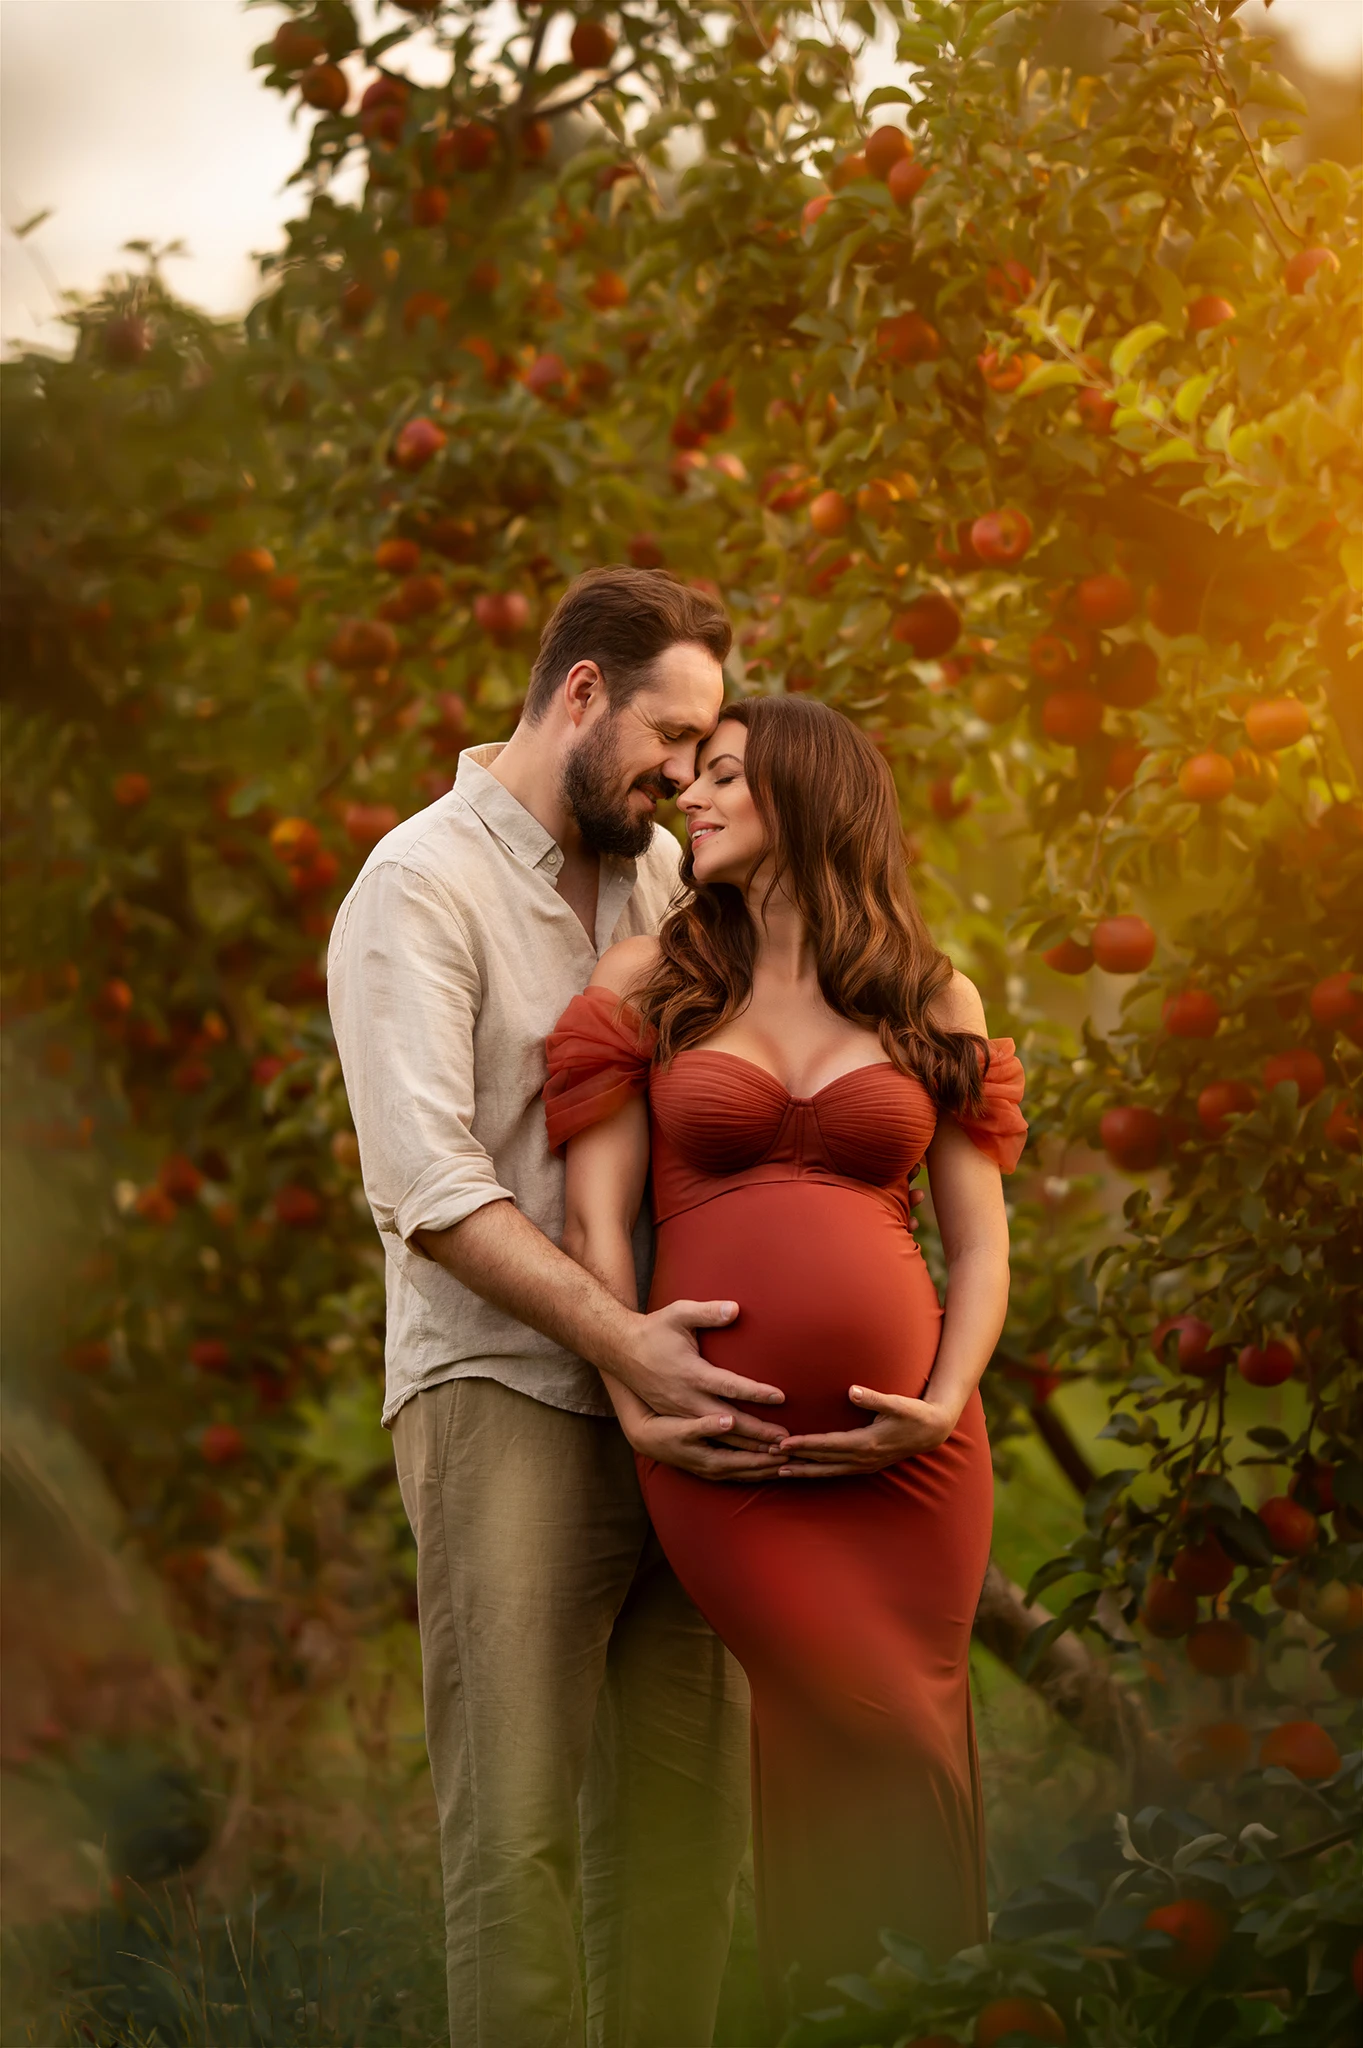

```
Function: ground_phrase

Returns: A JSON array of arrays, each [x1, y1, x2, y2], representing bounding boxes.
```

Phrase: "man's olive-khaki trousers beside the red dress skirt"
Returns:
[[393, 1380, 749, 2048]]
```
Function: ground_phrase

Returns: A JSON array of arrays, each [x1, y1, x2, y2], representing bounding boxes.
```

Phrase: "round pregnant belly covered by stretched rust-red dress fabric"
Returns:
[[649, 1180, 941, 1434]]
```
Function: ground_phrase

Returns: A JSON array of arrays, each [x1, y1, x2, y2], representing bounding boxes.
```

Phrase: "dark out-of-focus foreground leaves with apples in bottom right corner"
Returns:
[[782, 1772, 1363, 2048]]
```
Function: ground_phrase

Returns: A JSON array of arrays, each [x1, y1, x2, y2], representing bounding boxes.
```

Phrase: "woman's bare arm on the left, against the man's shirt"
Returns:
[[563, 938, 776, 1479]]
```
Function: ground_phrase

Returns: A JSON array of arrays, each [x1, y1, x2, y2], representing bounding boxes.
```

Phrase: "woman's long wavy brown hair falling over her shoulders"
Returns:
[[630, 696, 988, 1110]]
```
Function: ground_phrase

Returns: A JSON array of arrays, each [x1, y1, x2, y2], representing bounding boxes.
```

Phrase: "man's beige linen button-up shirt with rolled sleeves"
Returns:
[[327, 745, 679, 1423]]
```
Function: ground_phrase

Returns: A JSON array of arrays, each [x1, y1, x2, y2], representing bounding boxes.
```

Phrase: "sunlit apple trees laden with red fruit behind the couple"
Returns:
[[2, 0, 1363, 2044]]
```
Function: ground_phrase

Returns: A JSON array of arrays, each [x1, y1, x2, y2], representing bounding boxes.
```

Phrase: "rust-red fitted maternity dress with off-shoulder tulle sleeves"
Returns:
[[544, 989, 1027, 2013]]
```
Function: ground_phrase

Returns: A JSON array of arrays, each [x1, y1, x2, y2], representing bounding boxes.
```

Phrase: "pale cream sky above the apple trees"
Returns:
[[0, 0, 1363, 346]]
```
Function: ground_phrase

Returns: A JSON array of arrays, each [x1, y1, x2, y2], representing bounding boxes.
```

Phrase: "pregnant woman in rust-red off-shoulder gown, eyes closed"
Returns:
[[544, 696, 1025, 2019]]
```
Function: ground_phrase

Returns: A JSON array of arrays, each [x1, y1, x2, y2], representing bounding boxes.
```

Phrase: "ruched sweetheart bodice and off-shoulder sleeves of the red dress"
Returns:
[[544, 987, 1027, 1223]]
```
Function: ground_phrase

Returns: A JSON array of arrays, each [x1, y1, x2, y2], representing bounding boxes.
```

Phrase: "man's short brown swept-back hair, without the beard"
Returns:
[[524, 565, 733, 725]]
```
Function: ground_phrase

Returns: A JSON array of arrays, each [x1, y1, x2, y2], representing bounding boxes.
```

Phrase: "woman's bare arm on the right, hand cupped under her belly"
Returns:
[[782, 975, 1009, 1479]]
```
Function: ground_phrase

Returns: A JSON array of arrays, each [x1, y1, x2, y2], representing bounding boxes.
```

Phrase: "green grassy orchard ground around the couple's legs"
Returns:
[[0, 1444, 1117, 2048]]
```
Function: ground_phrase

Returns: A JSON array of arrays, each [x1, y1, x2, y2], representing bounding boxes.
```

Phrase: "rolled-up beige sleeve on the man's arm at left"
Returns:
[[327, 862, 514, 1251]]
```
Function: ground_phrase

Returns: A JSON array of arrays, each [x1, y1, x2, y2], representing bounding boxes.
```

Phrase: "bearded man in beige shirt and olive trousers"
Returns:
[[327, 567, 782, 2048]]
